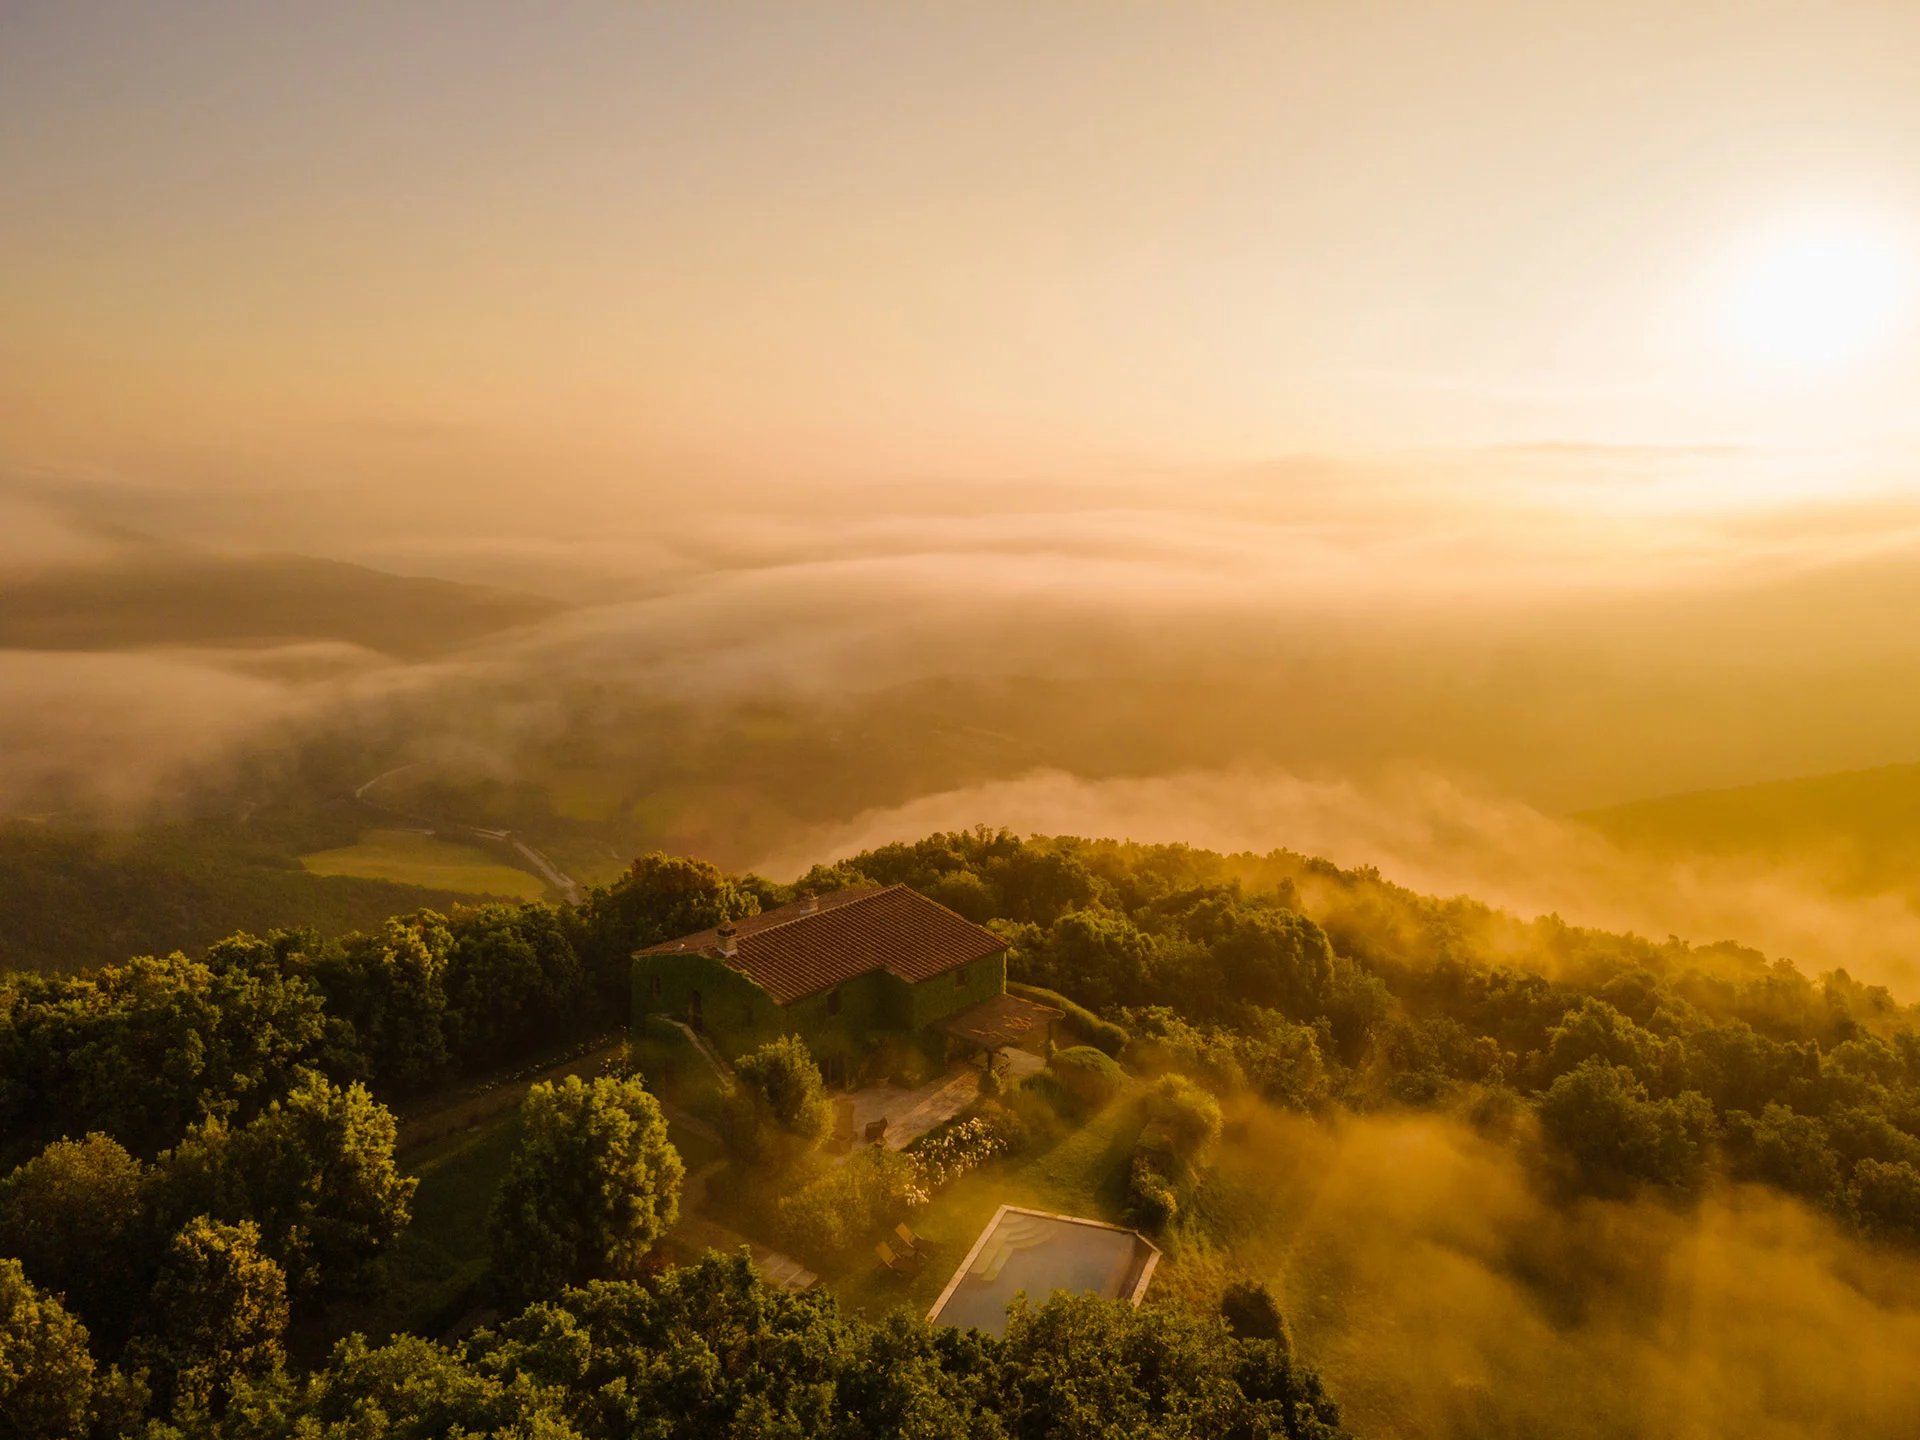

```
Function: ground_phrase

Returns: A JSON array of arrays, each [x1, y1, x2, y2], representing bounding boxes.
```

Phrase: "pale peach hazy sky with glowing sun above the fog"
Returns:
[[0, 0, 1920, 499]]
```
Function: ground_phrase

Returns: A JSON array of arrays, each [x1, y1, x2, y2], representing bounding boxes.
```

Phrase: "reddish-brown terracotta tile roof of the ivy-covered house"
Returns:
[[636, 885, 1006, 1004]]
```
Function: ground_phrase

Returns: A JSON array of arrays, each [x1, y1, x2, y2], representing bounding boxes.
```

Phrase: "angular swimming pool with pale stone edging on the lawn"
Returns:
[[927, 1206, 1160, 1334]]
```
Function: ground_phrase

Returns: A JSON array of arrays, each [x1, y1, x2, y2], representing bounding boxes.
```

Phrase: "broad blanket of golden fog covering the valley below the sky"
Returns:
[[0, 447, 1920, 981]]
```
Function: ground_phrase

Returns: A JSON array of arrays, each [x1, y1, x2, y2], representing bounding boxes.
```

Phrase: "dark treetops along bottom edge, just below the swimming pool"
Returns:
[[183, 1256, 1344, 1440]]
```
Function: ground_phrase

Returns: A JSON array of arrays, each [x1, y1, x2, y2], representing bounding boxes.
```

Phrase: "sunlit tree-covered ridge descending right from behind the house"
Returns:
[[803, 829, 1920, 1240]]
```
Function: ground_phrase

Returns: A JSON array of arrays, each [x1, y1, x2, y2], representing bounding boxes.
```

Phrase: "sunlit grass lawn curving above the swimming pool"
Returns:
[[822, 1096, 1142, 1317]]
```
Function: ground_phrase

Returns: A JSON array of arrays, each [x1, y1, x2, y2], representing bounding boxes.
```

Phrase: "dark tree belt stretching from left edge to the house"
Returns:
[[0, 904, 589, 1162]]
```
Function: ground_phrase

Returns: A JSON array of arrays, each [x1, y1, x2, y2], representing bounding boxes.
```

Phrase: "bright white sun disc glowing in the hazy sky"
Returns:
[[1724, 215, 1914, 374]]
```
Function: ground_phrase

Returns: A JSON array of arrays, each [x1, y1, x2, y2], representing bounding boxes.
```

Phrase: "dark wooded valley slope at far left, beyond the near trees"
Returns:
[[0, 826, 503, 972]]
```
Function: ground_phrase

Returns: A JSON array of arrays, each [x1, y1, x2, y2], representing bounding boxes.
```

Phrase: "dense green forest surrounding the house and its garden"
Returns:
[[11, 829, 1920, 1440]]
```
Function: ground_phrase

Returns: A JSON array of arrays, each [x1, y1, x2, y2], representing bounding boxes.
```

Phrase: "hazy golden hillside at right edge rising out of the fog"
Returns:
[[1580, 764, 1920, 893]]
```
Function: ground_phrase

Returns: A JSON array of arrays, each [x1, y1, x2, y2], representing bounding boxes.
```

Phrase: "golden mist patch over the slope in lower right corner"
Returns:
[[1221, 1110, 1920, 1440]]
